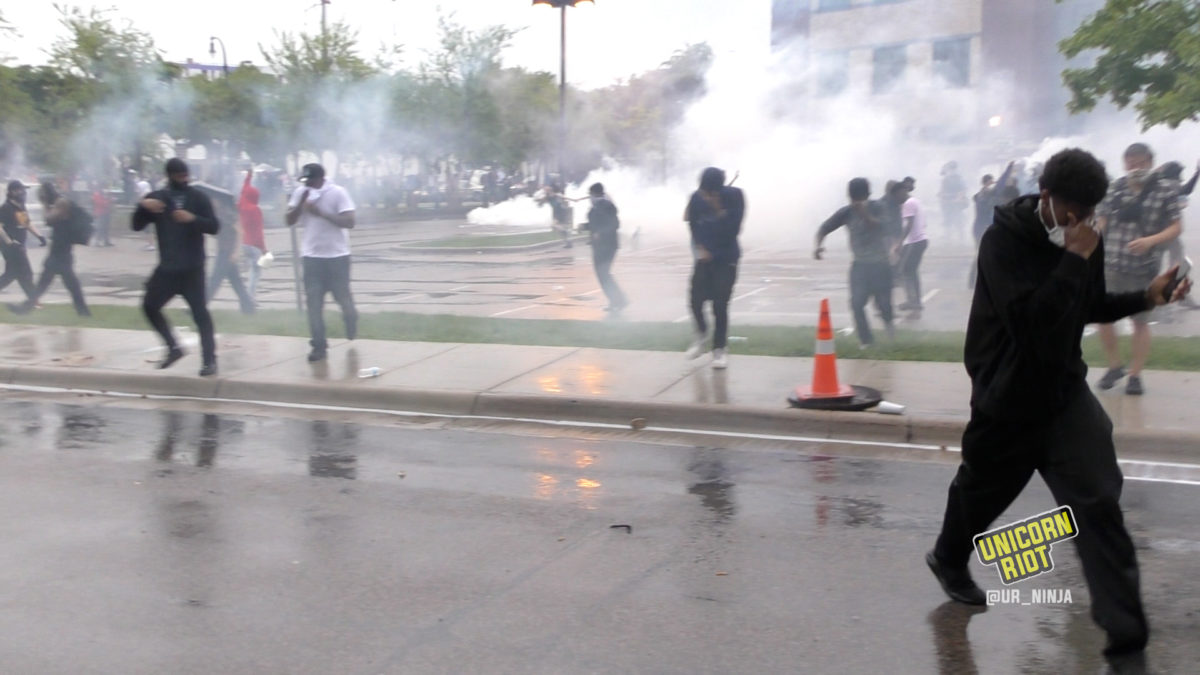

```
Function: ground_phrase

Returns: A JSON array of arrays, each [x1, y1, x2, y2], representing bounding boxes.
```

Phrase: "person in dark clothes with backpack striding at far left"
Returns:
[[8, 180, 91, 316]]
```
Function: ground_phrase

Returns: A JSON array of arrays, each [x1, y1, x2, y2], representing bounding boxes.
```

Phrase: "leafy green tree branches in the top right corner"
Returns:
[[1058, 0, 1200, 129]]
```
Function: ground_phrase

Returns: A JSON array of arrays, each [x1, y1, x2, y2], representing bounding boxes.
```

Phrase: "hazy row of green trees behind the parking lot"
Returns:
[[0, 5, 712, 177]]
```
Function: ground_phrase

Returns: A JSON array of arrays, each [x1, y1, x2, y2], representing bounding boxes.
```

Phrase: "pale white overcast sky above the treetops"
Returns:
[[0, 0, 770, 89]]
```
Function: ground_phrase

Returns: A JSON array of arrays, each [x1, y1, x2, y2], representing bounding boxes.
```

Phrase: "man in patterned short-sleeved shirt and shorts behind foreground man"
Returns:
[[1097, 143, 1183, 396]]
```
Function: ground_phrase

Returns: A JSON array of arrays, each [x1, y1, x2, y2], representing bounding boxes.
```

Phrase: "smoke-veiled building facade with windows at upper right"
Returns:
[[772, 0, 1103, 143]]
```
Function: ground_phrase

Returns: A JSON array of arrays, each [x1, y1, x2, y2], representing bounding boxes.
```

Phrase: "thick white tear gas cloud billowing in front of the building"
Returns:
[[473, 21, 1200, 252]]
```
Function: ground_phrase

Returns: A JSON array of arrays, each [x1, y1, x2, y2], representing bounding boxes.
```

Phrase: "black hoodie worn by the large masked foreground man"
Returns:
[[964, 195, 1150, 420]]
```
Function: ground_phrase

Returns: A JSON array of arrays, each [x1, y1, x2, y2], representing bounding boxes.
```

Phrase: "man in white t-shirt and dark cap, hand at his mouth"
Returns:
[[287, 163, 359, 362]]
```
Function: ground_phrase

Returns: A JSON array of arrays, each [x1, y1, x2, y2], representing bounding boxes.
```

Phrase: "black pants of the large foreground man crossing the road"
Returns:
[[935, 382, 1150, 646]]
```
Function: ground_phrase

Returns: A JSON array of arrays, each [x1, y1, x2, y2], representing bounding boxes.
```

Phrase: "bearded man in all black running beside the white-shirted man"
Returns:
[[133, 157, 221, 377]]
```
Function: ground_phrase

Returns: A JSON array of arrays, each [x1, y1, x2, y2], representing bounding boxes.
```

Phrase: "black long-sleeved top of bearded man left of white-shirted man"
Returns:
[[133, 186, 221, 271]]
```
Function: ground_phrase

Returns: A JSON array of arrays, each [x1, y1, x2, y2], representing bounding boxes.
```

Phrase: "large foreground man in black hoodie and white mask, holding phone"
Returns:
[[925, 149, 1190, 657]]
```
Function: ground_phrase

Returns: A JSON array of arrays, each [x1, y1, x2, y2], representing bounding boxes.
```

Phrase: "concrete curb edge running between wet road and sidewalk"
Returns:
[[0, 365, 1200, 461]]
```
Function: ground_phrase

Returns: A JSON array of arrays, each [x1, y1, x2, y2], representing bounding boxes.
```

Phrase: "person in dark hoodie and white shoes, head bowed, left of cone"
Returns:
[[683, 167, 746, 369]]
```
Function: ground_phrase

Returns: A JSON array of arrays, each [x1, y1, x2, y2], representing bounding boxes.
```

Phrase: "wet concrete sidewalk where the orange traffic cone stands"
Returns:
[[0, 325, 1200, 458]]
